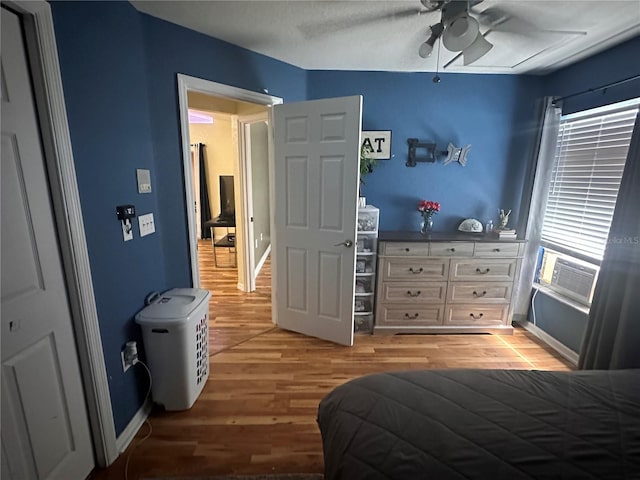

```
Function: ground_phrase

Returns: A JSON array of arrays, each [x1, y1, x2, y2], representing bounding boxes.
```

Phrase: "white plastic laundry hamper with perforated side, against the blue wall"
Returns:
[[136, 288, 211, 410]]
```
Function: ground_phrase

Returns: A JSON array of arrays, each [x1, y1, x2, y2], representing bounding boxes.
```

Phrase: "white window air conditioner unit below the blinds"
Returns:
[[540, 250, 598, 305]]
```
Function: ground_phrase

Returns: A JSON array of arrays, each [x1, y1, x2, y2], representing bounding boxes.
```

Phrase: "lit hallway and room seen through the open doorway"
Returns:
[[187, 91, 271, 292]]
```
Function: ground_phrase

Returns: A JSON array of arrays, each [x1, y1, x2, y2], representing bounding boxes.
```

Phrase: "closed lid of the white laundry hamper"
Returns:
[[136, 288, 211, 325]]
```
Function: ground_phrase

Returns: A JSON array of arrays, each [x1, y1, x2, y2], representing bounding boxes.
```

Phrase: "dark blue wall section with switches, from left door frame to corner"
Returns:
[[51, 2, 168, 434]]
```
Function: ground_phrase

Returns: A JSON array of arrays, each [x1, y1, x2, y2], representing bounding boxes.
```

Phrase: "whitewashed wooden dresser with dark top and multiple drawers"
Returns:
[[374, 232, 524, 334]]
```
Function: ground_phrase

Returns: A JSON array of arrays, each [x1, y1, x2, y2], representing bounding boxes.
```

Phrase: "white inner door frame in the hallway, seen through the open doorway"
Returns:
[[238, 111, 271, 292]]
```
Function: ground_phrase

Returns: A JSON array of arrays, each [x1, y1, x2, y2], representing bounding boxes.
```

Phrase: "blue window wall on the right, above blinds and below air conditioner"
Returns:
[[530, 37, 640, 352]]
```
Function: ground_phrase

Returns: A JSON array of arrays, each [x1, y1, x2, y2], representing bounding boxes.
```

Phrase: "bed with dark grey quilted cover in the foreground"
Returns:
[[318, 370, 640, 480]]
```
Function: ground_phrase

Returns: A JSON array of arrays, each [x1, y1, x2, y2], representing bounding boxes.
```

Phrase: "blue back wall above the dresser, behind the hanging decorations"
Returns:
[[308, 71, 539, 232]]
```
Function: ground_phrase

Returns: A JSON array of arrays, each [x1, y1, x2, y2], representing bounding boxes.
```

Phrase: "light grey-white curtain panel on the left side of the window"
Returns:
[[514, 97, 562, 321]]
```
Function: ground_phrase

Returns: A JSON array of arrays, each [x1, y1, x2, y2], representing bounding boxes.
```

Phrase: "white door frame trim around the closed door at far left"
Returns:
[[3, 0, 118, 467]]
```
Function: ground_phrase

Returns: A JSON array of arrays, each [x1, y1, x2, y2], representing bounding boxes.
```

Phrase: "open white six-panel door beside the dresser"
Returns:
[[273, 96, 362, 345]]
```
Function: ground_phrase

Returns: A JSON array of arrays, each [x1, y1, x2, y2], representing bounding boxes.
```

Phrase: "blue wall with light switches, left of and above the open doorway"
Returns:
[[51, 2, 306, 434]]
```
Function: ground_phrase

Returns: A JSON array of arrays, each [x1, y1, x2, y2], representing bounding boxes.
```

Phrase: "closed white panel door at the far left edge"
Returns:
[[1, 8, 94, 480]]
